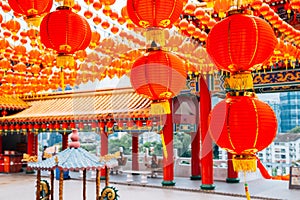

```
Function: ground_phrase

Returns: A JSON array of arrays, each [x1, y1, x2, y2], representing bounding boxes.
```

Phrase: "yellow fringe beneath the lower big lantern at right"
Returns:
[[232, 155, 257, 172]]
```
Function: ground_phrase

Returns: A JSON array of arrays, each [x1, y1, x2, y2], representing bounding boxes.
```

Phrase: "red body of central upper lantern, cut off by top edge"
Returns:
[[126, 0, 184, 28]]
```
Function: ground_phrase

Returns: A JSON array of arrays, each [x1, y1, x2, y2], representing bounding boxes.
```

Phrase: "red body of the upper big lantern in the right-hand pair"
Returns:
[[206, 14, 277, 72]]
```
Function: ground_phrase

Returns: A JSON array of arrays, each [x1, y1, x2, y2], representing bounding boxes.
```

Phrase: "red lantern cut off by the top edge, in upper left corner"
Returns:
[[8, 0, 53, 26]]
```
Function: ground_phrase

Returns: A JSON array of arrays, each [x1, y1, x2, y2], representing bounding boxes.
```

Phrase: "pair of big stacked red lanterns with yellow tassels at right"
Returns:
[[206, 3, 277, 199]]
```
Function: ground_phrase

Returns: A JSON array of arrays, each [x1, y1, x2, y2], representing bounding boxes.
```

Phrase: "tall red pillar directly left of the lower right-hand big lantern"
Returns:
[[200, 76, 215, 190]]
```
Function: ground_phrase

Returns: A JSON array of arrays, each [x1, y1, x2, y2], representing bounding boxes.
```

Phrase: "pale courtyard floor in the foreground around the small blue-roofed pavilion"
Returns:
[[0, 173, 262, 200]]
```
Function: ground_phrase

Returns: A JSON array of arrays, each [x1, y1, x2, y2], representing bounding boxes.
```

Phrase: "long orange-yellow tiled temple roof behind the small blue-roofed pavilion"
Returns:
[[0, 88, 151, 122]]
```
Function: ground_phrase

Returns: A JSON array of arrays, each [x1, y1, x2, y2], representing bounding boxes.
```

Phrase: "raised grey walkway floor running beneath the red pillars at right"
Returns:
[[105, 175, 300, 200]]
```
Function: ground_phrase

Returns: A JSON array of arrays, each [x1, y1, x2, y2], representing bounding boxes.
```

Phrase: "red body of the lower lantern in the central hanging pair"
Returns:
[[130, 50, 186, 100]]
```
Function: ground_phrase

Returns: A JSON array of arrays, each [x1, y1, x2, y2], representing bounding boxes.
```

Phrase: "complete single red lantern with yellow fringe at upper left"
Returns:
[[40, 6, 92, 67]]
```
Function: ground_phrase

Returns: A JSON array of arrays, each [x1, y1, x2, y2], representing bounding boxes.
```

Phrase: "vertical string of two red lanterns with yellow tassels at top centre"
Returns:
[[127, 0, 187, 157]]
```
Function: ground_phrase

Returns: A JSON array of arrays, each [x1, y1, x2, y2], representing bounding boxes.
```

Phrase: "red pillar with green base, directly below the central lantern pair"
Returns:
[[162, 99, 175, 186]]
